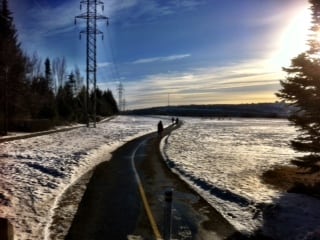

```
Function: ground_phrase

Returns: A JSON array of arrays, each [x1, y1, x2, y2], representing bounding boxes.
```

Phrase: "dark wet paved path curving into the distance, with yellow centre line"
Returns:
[[66, 126, 235, 240]]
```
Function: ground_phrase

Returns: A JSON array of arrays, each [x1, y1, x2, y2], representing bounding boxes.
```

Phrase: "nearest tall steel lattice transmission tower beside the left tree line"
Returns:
[[75, 0, 109, 127]]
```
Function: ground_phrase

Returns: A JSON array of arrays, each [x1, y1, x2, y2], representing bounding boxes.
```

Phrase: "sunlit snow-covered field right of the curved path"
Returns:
[[162, 118, 320, 239]]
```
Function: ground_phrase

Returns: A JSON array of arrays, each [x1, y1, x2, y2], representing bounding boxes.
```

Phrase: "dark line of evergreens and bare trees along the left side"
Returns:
[[0, 0, 118, 134]]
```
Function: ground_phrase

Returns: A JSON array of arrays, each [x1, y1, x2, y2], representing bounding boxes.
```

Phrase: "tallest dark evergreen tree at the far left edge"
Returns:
[[0, 0, 26, 134]]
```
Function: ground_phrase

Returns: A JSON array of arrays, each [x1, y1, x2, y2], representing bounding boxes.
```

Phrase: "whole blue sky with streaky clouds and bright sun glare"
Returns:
[[9, 0, 310, 109]]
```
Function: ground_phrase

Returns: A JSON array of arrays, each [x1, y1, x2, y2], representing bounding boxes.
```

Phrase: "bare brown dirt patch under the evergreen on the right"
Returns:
[[262, 166, 320, 198]]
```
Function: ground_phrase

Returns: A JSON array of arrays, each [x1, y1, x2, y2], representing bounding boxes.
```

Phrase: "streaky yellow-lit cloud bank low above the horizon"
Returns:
[[124, 61, 280, 108]]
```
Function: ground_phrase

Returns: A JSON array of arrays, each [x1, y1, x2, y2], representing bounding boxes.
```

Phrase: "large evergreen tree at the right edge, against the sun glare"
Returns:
[[276, 0, 320, 170]]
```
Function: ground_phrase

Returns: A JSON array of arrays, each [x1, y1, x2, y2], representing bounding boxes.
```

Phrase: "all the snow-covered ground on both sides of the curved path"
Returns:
[[0, 116, 320, 240]]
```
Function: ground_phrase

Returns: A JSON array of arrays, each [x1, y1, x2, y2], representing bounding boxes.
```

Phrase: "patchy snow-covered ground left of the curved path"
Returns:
[[0, 116, 169, 240]]
